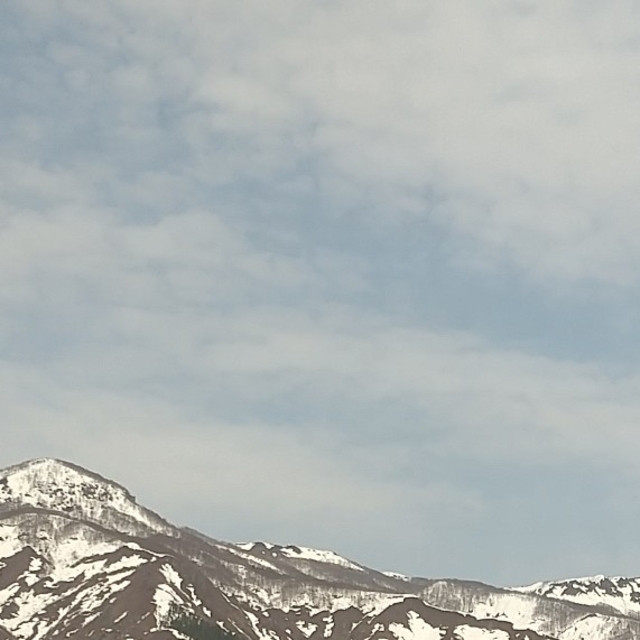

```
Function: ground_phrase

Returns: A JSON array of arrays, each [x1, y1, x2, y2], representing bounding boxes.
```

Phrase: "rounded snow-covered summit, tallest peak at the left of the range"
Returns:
[[0, 458, 174, 535]]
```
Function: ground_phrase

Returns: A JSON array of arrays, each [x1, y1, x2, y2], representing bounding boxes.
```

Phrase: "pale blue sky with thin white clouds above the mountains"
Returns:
[[0, 0, 640, 585]]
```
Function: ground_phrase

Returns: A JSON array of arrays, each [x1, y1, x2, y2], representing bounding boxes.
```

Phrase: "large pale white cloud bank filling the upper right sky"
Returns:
[[32, 0, 640, 285]]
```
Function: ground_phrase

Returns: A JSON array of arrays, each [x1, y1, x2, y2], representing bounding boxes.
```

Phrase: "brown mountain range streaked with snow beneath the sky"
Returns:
[[0, 459, 640, 640]]
